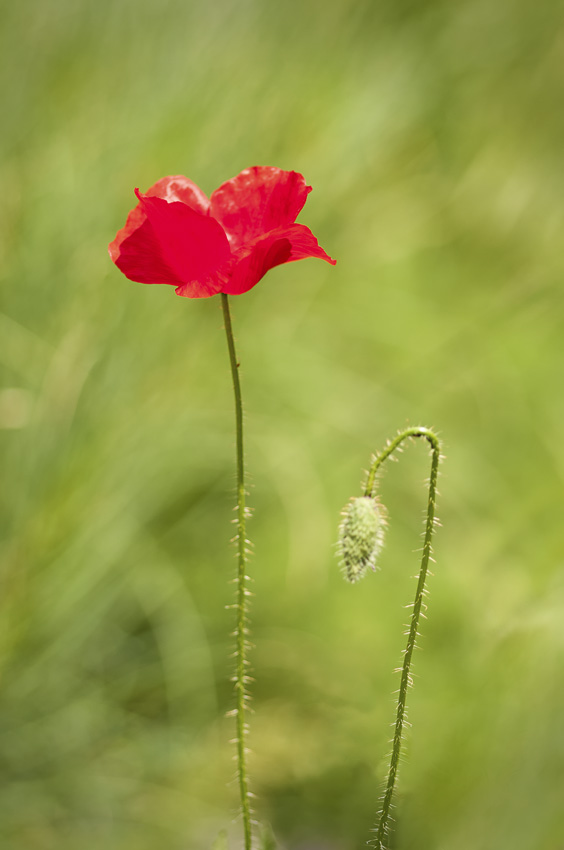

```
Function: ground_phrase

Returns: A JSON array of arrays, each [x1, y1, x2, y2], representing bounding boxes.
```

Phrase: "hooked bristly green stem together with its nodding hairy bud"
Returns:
[[339, 427, 441, 850]]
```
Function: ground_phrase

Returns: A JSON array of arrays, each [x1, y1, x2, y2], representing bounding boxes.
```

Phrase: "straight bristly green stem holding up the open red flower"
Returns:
[[221, 292, 252, 850]]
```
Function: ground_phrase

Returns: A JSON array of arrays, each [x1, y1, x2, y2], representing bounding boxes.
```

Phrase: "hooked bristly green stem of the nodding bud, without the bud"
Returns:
[[365, 428, 440, 850]]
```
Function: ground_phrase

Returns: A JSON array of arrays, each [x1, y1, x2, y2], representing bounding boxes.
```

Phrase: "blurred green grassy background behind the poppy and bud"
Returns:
[[0, 0, 564, 850]]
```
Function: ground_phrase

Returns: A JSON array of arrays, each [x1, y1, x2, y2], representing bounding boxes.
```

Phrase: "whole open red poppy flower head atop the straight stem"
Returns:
[[109, 166, 336, 298]]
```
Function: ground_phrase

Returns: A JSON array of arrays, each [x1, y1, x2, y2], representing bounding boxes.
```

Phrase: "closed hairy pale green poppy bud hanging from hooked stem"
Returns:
[[338, 496, 386, 583]]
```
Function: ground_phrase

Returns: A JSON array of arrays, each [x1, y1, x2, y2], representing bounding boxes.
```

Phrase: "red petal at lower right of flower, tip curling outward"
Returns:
[[221, 224, 337, 295]]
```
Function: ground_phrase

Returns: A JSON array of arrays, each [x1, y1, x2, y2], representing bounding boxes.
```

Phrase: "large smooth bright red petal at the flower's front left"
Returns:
[[115, 189, 231, 298]]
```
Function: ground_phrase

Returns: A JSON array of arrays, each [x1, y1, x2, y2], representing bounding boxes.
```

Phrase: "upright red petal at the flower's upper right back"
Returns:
[[210, 165, 311, 250]]
